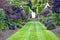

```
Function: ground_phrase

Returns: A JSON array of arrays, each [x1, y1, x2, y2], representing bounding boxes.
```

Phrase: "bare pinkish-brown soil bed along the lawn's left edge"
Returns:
[[0, 28, 19, 40]]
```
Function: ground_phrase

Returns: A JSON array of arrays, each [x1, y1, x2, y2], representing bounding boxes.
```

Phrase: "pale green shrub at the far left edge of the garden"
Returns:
[[0, 9, 7, 30]]
